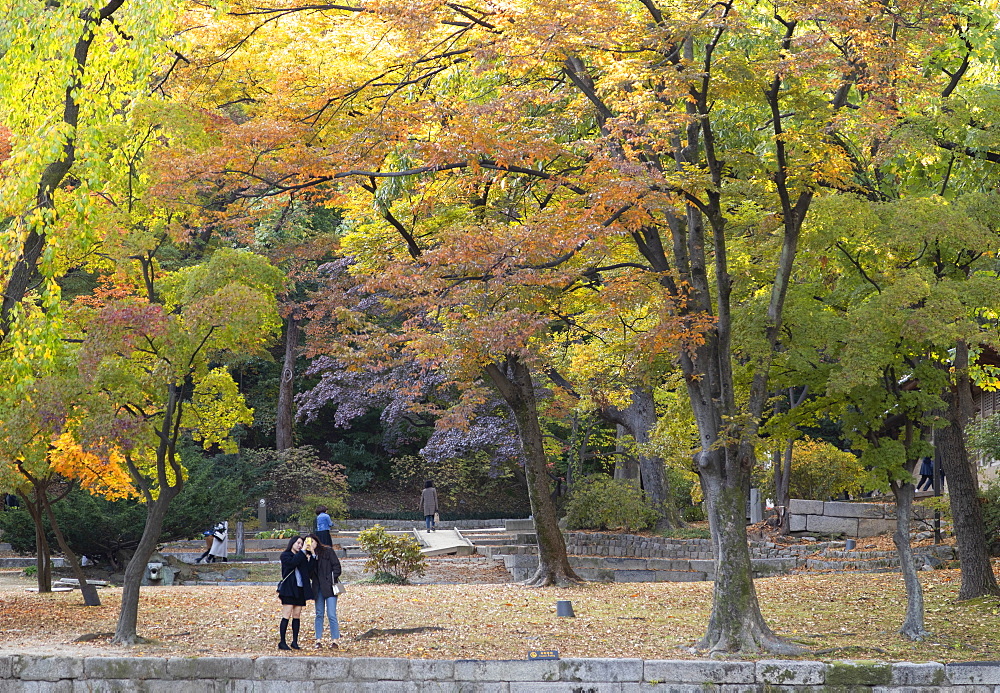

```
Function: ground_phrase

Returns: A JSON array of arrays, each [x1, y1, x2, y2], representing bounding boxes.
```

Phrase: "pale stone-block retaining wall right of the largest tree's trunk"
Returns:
[[788, 499, 933, 537]]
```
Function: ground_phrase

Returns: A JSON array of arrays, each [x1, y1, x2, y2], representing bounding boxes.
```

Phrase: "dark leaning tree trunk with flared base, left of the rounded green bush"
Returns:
[[486, 355, 580, 587]]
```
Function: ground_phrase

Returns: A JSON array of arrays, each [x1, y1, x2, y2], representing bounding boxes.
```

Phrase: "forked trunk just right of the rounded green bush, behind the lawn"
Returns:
[[601, 387, 681, 530]]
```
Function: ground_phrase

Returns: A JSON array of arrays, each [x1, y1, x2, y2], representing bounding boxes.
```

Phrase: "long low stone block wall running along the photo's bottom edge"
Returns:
[[0, 654, 1000, 693]]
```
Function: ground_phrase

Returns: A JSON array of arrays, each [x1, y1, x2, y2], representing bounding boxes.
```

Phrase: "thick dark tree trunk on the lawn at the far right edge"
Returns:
[[934, 342, 1000, 599]]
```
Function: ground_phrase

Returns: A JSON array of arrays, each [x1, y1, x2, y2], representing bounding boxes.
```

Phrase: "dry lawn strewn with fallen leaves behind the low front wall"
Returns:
[[0, 570, 1000, 662]]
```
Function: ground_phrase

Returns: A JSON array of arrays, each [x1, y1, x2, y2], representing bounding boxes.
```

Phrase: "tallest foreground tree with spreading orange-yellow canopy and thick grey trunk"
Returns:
[[158, 0, 976, 652]]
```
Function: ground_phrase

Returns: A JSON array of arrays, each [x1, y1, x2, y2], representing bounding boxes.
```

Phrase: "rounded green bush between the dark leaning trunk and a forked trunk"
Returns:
[[566, 475, 657, 531]]
